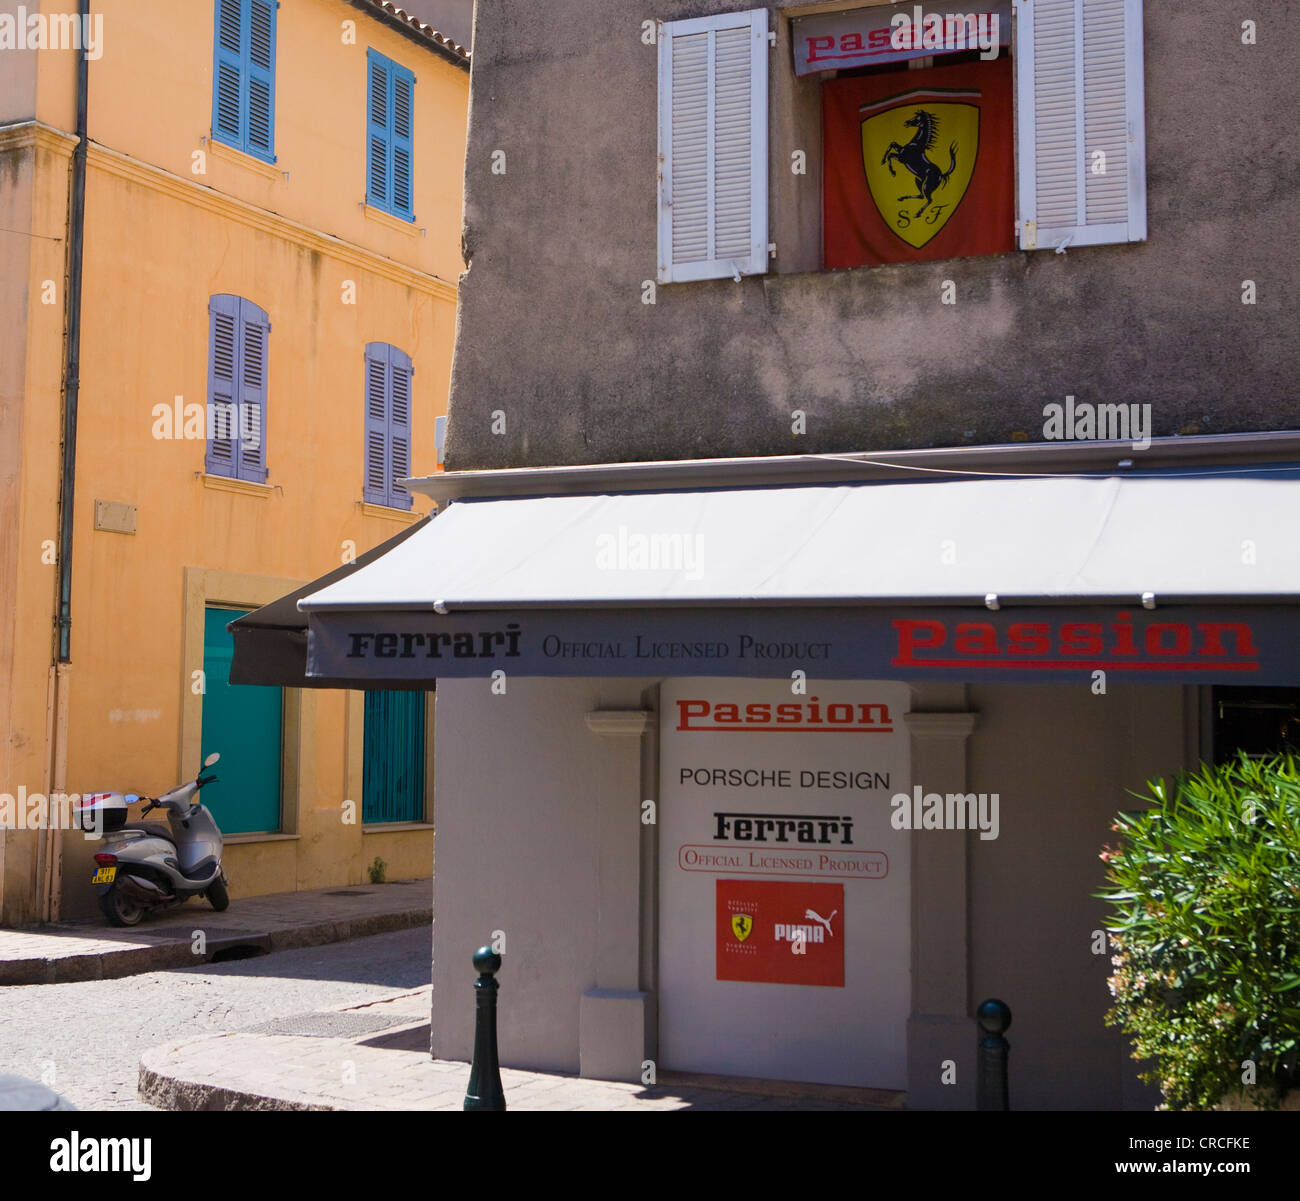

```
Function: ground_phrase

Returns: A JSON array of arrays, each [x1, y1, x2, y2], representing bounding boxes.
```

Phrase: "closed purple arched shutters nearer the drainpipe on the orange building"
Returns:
[[204, 295, 270, 484]]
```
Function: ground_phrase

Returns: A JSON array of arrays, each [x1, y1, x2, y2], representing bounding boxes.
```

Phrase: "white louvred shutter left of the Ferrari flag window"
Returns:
[[659, 8, 770, 283]]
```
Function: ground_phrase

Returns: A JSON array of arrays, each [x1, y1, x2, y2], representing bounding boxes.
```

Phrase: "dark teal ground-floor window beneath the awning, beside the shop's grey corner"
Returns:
[[361, 691, 425, 825]]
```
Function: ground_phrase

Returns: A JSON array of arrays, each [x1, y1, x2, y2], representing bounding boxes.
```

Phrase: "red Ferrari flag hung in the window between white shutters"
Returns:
[[822, 58, 1015, 268]]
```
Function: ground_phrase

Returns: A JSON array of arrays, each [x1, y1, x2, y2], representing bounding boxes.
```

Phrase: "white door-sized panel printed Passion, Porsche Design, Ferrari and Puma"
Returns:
[[657, 677, 918, 1088]]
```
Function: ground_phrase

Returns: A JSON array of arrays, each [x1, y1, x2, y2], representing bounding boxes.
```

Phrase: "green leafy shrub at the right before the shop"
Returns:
[[1099, 755, 1300, 1110]]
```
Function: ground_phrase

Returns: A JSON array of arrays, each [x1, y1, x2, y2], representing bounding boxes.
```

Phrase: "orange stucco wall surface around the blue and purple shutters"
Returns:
[[0, 0, 469, 923]]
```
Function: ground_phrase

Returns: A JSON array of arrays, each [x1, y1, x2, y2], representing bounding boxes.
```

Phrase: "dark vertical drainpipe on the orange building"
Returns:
[[36, 0, 90, 922]]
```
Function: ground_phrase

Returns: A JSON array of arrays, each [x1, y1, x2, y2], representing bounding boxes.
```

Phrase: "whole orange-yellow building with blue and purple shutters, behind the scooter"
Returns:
[[0, 0, 469, 924]]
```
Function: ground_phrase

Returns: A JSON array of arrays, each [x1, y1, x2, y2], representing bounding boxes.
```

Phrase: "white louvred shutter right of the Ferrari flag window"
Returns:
[[1015, 0, 1147, 250]]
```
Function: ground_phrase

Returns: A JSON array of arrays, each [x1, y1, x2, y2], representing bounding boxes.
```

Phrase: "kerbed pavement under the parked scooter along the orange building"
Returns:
[[0, 879, 433, 985]]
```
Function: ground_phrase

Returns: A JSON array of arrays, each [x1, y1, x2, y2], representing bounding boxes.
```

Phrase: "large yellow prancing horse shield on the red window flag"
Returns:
[[859, 88, 980, 250]]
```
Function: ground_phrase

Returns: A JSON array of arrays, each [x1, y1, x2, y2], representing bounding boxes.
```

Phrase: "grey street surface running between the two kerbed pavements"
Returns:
[[0, 927, 430, 1110]]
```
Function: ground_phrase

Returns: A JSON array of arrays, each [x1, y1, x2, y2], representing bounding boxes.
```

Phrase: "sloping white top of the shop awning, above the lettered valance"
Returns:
[[298, 471, 1300, 613]]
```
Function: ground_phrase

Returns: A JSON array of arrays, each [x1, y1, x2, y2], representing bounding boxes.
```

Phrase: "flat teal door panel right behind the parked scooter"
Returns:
[[200, 608, 283, 834]]
